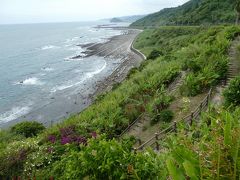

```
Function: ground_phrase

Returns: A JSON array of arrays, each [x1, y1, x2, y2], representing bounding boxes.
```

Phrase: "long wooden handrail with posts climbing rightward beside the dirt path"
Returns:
[[134, 88, 212, 151]]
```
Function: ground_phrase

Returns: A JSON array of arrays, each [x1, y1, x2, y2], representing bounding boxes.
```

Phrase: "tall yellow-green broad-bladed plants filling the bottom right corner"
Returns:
[[166, 109, 240, 179]]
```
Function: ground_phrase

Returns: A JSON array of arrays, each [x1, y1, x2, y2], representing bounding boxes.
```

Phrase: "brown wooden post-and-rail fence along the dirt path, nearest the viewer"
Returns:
[[134, 89, 212, 152]]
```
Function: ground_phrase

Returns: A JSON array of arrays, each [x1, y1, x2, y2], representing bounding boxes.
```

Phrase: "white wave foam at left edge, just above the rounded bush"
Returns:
[[0, 106, 31, 123]]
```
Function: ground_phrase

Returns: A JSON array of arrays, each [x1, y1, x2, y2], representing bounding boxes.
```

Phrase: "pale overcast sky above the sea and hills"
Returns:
[[0, 0, 188, 24]]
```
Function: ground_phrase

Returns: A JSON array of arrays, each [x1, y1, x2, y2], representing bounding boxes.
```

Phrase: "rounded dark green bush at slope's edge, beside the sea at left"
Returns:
[[11, 121, 45, 138]]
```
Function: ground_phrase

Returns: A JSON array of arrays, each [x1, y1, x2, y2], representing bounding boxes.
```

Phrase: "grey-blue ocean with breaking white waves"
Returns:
[[0, 22, 127, 127]]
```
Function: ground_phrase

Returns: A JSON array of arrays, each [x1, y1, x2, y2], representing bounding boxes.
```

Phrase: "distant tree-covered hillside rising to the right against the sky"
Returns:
[[131, 0, 236, 27]]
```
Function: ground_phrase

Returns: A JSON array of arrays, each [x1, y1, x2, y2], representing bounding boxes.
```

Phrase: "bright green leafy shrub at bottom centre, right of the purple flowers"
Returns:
[[51, 139, 166, 180]]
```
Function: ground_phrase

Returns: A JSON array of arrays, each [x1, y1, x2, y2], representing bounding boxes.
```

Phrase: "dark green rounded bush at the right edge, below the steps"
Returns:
[[223, 76, 240, 106]]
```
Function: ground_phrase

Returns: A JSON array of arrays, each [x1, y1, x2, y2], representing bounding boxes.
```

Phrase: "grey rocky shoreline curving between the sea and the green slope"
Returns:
[[1, 27, 144, 129]]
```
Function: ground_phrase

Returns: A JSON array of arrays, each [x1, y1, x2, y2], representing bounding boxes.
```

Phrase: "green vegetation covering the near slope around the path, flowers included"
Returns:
[[0, 26, 240, 179]]
